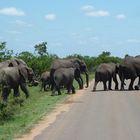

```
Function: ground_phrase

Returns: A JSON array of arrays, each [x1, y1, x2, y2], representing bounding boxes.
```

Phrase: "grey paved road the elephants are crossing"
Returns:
[[34, 79, 140, 140]]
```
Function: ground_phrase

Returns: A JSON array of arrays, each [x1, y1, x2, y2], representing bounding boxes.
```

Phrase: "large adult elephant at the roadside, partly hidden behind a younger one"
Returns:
[[50, 58, 89, 89]]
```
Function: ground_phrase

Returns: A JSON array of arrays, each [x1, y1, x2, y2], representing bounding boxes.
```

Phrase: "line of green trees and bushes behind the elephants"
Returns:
[[0, 42, 121, 75]]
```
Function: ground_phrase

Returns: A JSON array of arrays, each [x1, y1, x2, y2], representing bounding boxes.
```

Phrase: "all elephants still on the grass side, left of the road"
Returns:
[[0, 58, 89, 101]]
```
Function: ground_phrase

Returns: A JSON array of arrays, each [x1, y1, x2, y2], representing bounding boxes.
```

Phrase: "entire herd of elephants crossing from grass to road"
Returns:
[[0, 56, 140, 101]]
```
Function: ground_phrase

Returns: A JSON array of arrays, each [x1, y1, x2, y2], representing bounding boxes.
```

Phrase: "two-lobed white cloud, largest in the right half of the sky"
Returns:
[[81, 5, 110, 17]]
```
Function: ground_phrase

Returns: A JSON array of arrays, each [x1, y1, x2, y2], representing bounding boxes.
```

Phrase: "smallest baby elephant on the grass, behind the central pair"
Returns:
[[40, 71, 51, 91]]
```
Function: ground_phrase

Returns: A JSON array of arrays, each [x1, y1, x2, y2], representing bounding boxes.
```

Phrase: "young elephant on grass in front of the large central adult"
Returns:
[[52, 68, 80, 96]]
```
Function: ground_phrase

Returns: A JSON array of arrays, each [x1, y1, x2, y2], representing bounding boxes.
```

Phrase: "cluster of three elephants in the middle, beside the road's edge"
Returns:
[[40, 58, 89, 96]]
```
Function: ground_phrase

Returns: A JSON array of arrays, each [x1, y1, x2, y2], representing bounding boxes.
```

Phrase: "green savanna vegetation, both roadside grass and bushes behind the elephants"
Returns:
[[0, 42, 121, 140]]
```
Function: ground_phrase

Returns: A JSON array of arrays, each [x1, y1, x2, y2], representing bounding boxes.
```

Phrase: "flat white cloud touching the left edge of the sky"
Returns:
[[0, 7, 25, 16]]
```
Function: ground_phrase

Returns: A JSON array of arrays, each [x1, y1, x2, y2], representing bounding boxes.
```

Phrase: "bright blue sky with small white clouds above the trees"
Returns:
[[0, 0, 140, 57]]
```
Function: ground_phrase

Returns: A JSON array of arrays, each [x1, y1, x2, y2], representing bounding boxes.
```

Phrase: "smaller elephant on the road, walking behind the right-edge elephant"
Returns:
[[93, 63, 118, 91]]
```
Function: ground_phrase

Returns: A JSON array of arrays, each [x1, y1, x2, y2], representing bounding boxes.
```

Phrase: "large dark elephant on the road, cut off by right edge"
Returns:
[[119, 56, 140, 90]]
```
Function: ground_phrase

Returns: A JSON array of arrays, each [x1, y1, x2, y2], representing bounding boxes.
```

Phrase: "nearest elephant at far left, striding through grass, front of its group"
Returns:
[[0, 66, 34, 101]]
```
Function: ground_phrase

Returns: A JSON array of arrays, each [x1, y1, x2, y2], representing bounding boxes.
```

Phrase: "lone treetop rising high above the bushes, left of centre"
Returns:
[[34, 42, 48, 56]]
